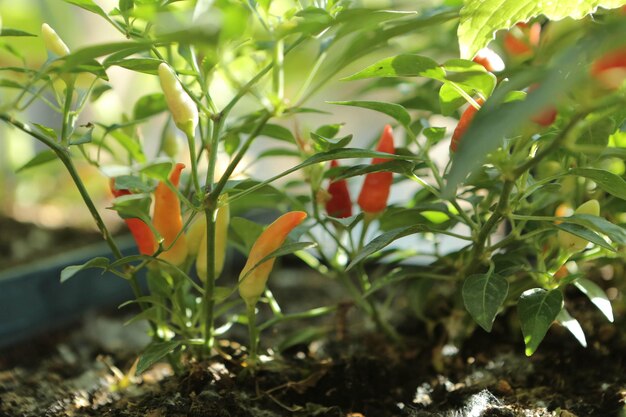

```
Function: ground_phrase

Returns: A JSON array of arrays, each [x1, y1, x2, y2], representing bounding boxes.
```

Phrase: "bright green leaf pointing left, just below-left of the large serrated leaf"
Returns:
[[343, 54, 446, 81]]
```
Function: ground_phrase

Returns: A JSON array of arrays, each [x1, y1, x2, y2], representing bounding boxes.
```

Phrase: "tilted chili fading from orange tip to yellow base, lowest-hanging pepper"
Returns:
[[239, 211, 306, 306]]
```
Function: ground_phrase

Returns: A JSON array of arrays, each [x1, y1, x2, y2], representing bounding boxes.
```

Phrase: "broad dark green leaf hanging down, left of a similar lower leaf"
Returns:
[[462, 274, 509, 332]]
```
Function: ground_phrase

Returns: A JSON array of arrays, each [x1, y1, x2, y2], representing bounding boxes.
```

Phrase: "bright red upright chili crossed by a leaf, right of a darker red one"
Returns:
[[358, 125, 395, 214]]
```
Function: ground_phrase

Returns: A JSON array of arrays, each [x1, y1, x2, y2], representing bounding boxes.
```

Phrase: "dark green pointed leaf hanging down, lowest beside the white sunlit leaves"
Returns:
[[517, 288, 563, 356]]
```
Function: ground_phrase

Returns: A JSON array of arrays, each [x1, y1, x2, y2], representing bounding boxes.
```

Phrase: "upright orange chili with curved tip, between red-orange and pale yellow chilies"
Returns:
[[152, 163, 187, 265]]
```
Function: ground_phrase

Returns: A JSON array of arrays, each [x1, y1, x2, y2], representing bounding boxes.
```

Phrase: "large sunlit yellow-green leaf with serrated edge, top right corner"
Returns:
[[457, 0, 626, 59]]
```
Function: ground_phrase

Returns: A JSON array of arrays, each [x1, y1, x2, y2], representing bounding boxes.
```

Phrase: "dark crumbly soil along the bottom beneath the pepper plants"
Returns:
[[0, 302, 626, 417]]
